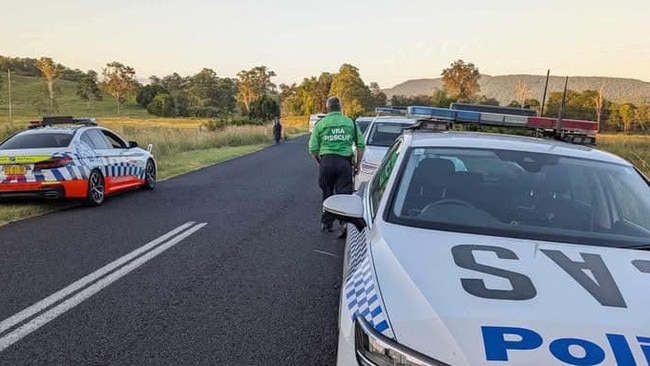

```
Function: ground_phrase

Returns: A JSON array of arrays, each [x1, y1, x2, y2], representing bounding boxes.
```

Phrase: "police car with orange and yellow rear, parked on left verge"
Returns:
[[0, 116, 157, 206]]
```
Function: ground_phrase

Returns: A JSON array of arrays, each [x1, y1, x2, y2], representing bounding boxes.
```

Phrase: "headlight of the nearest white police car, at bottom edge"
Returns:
[[354, 316, 450, 366]]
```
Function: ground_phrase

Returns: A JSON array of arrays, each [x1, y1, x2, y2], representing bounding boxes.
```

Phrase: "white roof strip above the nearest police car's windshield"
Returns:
[[410, 131, 632, 166]]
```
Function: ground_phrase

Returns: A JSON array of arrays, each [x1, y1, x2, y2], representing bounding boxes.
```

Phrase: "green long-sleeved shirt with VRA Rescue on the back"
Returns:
[[309, 112, 366, 157]]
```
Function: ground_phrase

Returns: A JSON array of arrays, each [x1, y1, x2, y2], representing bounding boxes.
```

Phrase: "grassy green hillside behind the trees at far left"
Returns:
[[0, 73, 149, 123]]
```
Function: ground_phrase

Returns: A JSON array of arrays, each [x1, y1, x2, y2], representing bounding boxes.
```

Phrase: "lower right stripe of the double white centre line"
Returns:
[[0, 223, 207, 352]]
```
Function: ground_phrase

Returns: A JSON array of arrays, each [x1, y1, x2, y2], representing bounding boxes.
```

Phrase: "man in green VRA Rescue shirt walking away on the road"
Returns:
[[309, 97, 366, 236]]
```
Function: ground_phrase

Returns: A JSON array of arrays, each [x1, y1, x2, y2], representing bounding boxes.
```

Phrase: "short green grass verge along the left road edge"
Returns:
[[0, 143, 269, 225]]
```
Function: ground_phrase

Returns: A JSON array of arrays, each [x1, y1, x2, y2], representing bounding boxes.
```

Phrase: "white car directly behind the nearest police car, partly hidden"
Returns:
[[354, 116, 417, 191]]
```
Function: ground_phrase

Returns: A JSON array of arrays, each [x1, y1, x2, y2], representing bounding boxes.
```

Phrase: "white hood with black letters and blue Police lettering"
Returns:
[[372, 223, 650, 366]]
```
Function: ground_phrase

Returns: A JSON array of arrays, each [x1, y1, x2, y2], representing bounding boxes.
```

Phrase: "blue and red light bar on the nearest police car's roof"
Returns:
[[407, 106, 598, 144]]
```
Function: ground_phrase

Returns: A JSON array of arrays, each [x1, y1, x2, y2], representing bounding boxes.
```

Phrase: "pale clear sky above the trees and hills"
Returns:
[[0, 0, 650, 88]]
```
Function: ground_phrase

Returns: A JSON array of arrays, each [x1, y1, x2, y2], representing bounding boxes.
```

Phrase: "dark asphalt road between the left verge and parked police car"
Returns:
[[0, 137, 343, 366]]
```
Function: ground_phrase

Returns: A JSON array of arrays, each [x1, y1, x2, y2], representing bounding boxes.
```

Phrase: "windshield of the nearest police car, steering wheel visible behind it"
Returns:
[[387, 148, 650, 246]]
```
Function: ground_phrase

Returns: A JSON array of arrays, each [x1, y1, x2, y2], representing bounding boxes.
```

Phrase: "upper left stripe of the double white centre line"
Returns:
[[0, 221, 195, 334]]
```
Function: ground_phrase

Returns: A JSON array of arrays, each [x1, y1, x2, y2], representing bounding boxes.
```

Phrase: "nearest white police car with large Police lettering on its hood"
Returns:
[[324, 107, 650, 366]]
